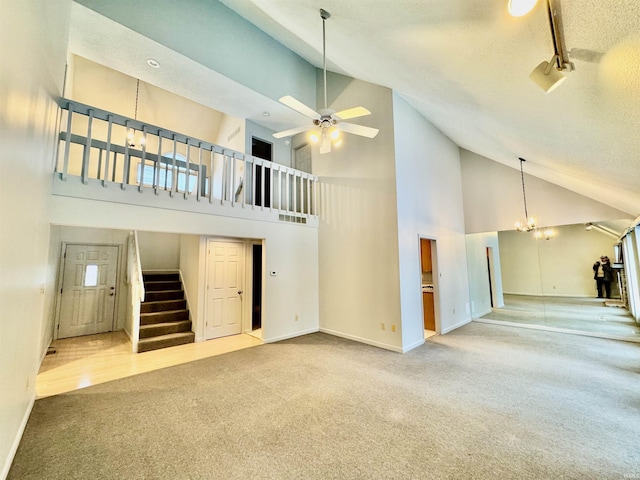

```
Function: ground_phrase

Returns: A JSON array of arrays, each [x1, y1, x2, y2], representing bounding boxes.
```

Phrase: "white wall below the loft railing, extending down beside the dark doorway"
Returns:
[[50, 195, 319, 342]]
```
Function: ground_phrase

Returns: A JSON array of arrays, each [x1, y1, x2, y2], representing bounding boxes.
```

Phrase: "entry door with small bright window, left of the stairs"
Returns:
[[58, 245, 118, 338]]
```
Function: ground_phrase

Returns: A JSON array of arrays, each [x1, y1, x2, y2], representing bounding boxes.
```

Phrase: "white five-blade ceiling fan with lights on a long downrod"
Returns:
[[273, 8, 378, 153]]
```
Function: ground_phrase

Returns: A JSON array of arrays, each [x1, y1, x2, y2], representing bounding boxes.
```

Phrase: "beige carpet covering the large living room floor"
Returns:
[[8, 323, 640, 480]]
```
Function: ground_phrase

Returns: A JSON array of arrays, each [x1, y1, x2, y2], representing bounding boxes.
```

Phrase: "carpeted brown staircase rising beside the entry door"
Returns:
[[138, 273, 195, 353]]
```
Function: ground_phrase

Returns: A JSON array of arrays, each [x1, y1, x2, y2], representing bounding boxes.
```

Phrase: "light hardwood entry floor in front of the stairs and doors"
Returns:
[[36, 331, 263, 398]]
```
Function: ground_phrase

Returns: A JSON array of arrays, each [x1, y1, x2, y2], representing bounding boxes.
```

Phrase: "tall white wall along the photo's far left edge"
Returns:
[[0, 0, 71, 472]]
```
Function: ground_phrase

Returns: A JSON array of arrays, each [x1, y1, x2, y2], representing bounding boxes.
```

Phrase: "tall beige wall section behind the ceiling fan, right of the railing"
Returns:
[[312, 74, 402, 350]]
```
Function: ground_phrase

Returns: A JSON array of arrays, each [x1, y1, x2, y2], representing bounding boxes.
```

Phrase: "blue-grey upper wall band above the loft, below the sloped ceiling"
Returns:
[[78, 0, 316, 105]]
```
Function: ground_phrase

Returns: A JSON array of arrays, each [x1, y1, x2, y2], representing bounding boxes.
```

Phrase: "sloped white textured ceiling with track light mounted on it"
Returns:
[[222, 0, 640, 215]]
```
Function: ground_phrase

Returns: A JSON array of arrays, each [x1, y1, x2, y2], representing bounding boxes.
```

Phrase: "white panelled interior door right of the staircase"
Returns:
[[205, 240, 244, 340]]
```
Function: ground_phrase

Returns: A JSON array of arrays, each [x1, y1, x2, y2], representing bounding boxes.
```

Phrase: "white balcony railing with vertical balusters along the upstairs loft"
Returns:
[[54, 99, 318, 223]]
